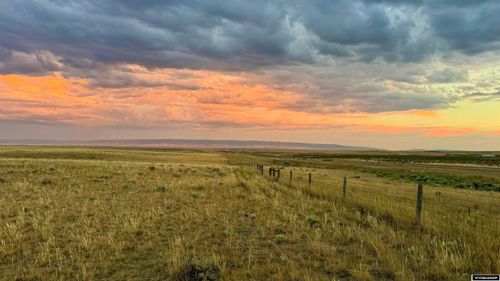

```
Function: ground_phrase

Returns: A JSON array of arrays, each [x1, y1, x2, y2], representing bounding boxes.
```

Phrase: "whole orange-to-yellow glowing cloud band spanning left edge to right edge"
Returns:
[[0, 65, 500, 142]]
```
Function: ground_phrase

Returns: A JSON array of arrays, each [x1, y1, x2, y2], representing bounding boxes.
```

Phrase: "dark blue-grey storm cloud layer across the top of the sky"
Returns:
[[0, 0, 500, 72]]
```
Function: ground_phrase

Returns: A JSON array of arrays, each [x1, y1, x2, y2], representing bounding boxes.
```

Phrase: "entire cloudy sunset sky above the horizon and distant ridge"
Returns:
[[0, 0, 500, 150]]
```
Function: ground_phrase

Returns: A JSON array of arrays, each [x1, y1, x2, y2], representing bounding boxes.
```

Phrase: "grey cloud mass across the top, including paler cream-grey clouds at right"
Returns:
[[0, 0, 500, 115]]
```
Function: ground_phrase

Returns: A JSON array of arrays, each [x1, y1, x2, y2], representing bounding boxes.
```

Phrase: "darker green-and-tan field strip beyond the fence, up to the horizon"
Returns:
[[226, 151, 500, 191]]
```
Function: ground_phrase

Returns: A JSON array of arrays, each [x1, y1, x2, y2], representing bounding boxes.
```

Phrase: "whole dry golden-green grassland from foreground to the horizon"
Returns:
[[0, 146, 500, 281]]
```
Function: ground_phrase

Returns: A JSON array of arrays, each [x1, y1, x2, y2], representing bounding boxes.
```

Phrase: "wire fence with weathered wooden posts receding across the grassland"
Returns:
[[254, 165, 500, 241]]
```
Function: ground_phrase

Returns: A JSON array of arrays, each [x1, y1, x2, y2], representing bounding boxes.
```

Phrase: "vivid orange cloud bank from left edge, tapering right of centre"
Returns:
[[0, 69, 346, 128]]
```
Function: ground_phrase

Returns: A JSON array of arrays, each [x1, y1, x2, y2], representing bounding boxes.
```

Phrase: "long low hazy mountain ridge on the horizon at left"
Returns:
[[0, 139, 379, 150]]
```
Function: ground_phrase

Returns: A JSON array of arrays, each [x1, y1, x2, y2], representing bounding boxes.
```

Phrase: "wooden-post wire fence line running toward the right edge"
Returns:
[[256, 165, 500, 237]]
